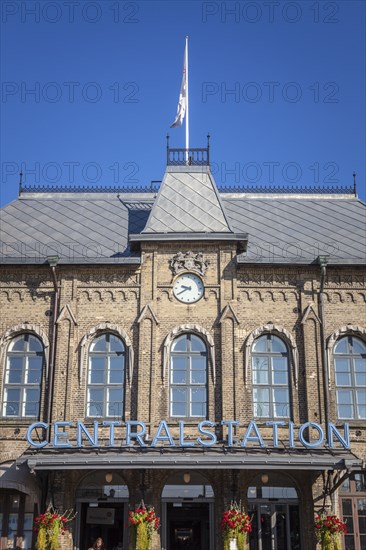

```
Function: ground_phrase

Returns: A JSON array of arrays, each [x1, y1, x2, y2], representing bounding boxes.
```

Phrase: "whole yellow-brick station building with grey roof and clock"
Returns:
[[0, 144, 366, 550]]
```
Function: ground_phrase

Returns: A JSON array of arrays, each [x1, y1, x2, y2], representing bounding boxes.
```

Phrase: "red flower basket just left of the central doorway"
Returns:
[[128, 502, 160, 550]]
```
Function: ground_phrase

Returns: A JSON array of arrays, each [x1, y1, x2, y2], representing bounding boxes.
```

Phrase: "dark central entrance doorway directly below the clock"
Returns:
[[167, 502, 210, 550]]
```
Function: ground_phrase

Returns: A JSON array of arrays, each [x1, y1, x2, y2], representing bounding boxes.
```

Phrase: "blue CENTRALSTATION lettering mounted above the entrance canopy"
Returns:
[[26, 420, 350, 449]]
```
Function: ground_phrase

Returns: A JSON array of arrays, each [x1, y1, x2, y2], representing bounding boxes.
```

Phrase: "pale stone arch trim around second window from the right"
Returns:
[[244, 324, 299, 388]]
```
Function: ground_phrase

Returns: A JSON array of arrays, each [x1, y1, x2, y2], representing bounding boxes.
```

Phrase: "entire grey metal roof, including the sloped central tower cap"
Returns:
[[0, 172, 366, 265]]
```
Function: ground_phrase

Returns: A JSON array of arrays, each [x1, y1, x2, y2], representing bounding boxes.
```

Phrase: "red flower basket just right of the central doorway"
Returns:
[[221, 502, 252, 550]]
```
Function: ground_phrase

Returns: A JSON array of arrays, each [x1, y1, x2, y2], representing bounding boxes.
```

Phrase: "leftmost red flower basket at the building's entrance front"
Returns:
[[34, 508, 76, 550]]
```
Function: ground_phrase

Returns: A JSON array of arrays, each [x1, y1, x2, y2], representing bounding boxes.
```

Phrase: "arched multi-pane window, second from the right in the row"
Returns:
[[252, 334, 290, 418]]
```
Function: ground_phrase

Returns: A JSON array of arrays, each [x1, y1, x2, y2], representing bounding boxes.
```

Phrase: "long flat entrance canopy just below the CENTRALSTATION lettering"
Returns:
[[17, 447, 363, 471]]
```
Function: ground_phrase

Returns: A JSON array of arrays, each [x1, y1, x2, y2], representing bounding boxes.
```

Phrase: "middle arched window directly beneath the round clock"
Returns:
[[170, 334, 207, 418]]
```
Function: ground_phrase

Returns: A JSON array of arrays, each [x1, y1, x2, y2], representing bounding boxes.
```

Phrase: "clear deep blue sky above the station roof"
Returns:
[[0, 0, 366, 205]]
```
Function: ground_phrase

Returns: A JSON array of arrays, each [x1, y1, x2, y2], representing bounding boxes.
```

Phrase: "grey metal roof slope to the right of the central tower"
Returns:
[[223, 195, 366, 265]]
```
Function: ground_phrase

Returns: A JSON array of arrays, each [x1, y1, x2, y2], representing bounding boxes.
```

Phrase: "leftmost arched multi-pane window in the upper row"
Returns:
[[2, 333, 44, 418]]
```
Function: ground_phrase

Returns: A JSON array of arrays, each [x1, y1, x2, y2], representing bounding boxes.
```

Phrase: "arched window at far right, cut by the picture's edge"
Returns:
[[334, 336, 366, 420]]
